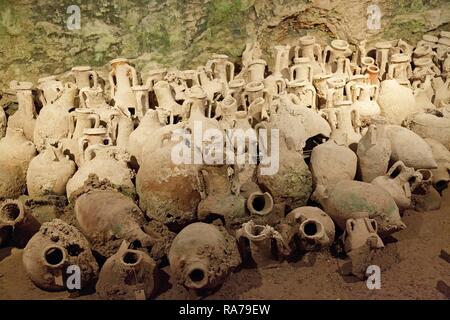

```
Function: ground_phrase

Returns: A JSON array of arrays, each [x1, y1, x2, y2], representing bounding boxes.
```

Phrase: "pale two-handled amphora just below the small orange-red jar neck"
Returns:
[[352, 84, 381, 117]]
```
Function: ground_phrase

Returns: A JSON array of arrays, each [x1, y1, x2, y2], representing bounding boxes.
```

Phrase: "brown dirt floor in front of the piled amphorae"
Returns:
[[0, 190, 450, 299]]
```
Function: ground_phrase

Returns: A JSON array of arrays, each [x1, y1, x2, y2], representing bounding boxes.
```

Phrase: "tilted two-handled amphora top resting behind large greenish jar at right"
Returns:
[[371, 161, 415, 210]]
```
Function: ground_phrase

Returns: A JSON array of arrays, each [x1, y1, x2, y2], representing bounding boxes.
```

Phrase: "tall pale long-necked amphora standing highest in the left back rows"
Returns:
[[109, 58, 138, 113]]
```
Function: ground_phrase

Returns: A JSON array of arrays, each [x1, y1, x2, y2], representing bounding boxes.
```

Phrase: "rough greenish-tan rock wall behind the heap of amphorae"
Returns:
[[0, 0, 450, 88]]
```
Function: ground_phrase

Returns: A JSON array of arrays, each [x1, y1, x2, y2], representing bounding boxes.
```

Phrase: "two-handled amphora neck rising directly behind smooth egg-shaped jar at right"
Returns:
[[322, 101, 361, 146]]
